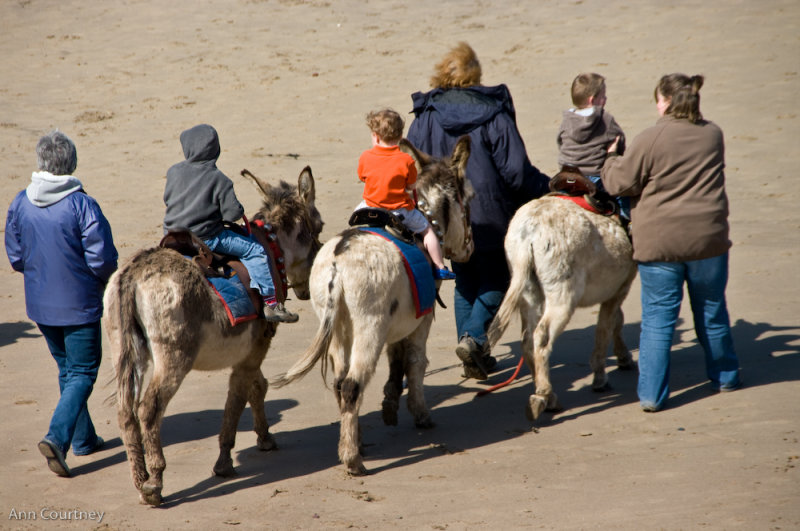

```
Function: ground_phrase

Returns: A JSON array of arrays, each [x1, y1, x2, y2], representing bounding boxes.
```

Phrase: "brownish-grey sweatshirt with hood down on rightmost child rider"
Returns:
[[556, 106, 625, 176]]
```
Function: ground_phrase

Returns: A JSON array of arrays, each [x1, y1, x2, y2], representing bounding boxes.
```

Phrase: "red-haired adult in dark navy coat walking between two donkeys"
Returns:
[[408, 42, 549, 379]]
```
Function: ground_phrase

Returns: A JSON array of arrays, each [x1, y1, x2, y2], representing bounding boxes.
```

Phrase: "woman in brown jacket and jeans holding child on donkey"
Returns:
[[602, 74, 740, 411]]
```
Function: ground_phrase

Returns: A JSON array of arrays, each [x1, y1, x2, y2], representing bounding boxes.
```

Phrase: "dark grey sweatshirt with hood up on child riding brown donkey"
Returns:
[[164, 124, 244, 240]]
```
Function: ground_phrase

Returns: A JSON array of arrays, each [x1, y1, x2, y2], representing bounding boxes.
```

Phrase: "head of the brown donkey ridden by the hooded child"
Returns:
[[242, 166, 323, 300]]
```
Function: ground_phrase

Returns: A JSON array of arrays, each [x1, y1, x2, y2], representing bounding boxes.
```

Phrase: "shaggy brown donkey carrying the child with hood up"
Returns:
[[104, 167, 322, 505]]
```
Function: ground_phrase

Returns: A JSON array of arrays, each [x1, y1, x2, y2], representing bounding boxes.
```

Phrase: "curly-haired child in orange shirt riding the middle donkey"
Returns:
[[356, 109, 456, 280]]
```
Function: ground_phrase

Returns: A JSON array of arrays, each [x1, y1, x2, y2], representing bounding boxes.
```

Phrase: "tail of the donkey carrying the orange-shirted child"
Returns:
[[270, 262, 342, 387]]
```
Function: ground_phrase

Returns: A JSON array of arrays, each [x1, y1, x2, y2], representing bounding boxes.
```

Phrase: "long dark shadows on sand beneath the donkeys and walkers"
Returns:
[[78, 320, 800, 508]]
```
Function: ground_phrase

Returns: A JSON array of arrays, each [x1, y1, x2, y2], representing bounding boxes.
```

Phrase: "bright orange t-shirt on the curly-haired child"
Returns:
[[358, 146, 417, 210]]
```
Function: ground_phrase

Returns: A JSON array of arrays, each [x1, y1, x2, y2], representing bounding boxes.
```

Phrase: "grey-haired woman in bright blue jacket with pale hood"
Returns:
[[5, 131, 117, 477]]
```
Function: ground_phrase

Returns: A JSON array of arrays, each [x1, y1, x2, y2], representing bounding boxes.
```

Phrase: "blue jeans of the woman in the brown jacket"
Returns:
[[638, 253, 739, 410]]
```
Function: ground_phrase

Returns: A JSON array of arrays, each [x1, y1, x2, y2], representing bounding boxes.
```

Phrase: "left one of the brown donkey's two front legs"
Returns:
[[213, 364, 258, 477]]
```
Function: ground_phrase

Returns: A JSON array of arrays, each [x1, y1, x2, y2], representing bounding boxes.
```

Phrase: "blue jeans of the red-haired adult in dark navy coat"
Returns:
[[452, 249, 511, 346]]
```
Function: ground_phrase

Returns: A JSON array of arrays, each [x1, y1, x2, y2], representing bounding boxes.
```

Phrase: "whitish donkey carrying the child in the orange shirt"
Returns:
[[271, 137, 474, 475]]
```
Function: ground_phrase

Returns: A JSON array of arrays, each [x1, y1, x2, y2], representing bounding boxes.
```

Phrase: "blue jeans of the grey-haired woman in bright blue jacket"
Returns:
[[37, 321, 103, 455]]
